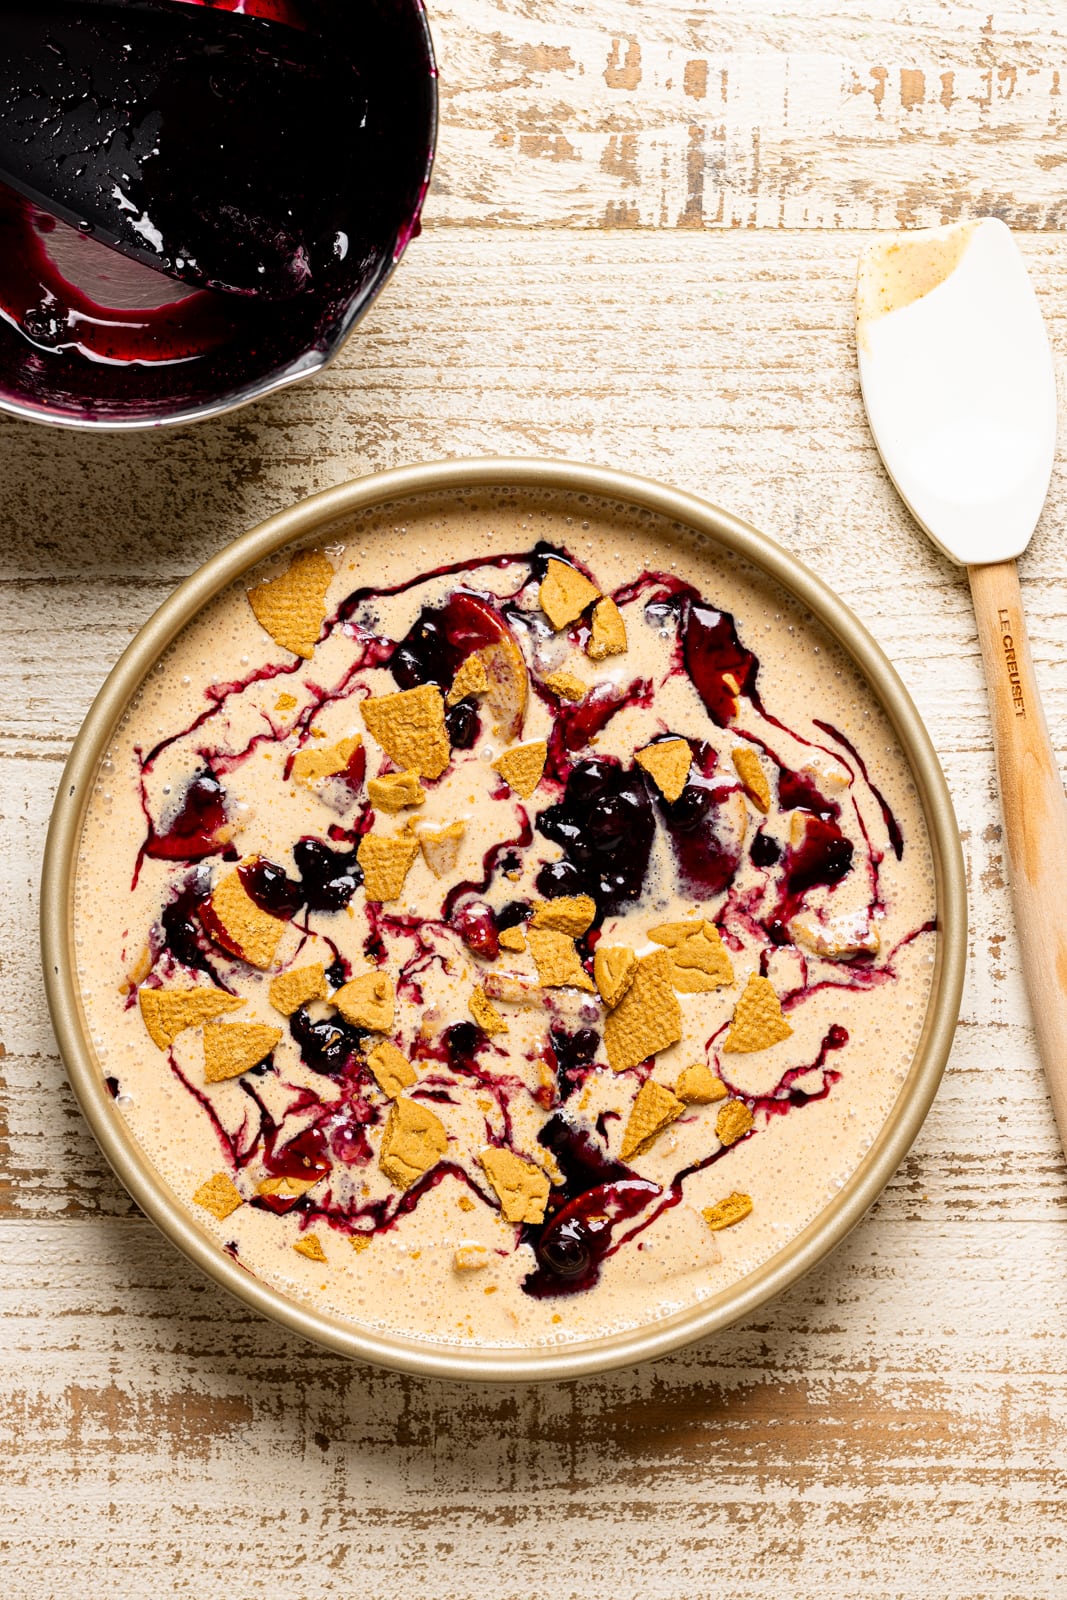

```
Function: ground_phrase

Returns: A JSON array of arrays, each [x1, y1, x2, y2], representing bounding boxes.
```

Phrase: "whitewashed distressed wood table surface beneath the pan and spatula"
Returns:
[[0, 0, 1067, 1600]]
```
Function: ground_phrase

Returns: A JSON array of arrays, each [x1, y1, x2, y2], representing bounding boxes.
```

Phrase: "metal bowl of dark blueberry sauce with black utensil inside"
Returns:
[[0, 0, 437, 429]]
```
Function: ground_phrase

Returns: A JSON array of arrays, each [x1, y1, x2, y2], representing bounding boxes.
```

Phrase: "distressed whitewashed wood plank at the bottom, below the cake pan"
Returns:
[[0, 1221, 1067, 1600]]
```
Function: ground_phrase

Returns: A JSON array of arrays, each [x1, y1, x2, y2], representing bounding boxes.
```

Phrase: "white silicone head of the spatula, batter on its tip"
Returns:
[[856, 218, 1056, 565]]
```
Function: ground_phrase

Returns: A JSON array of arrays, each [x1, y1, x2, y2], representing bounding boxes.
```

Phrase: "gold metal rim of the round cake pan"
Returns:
[[42, 458, 966, 1381]]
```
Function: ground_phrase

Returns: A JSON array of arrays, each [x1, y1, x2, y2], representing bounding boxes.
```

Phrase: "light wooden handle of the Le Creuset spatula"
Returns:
[[968, 562, 1067, 1152]]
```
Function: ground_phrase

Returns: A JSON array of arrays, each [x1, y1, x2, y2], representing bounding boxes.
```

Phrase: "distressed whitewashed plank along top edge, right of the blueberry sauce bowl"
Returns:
[[427, 0, 1065, 230]]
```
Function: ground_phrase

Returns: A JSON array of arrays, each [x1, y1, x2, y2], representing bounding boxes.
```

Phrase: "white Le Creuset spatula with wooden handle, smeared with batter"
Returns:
[[856, 218, 1067, 1150]]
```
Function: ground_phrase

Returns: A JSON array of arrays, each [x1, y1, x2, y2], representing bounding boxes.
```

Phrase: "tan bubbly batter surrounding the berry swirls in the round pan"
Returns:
[[75, 494, 936, 1346]]
